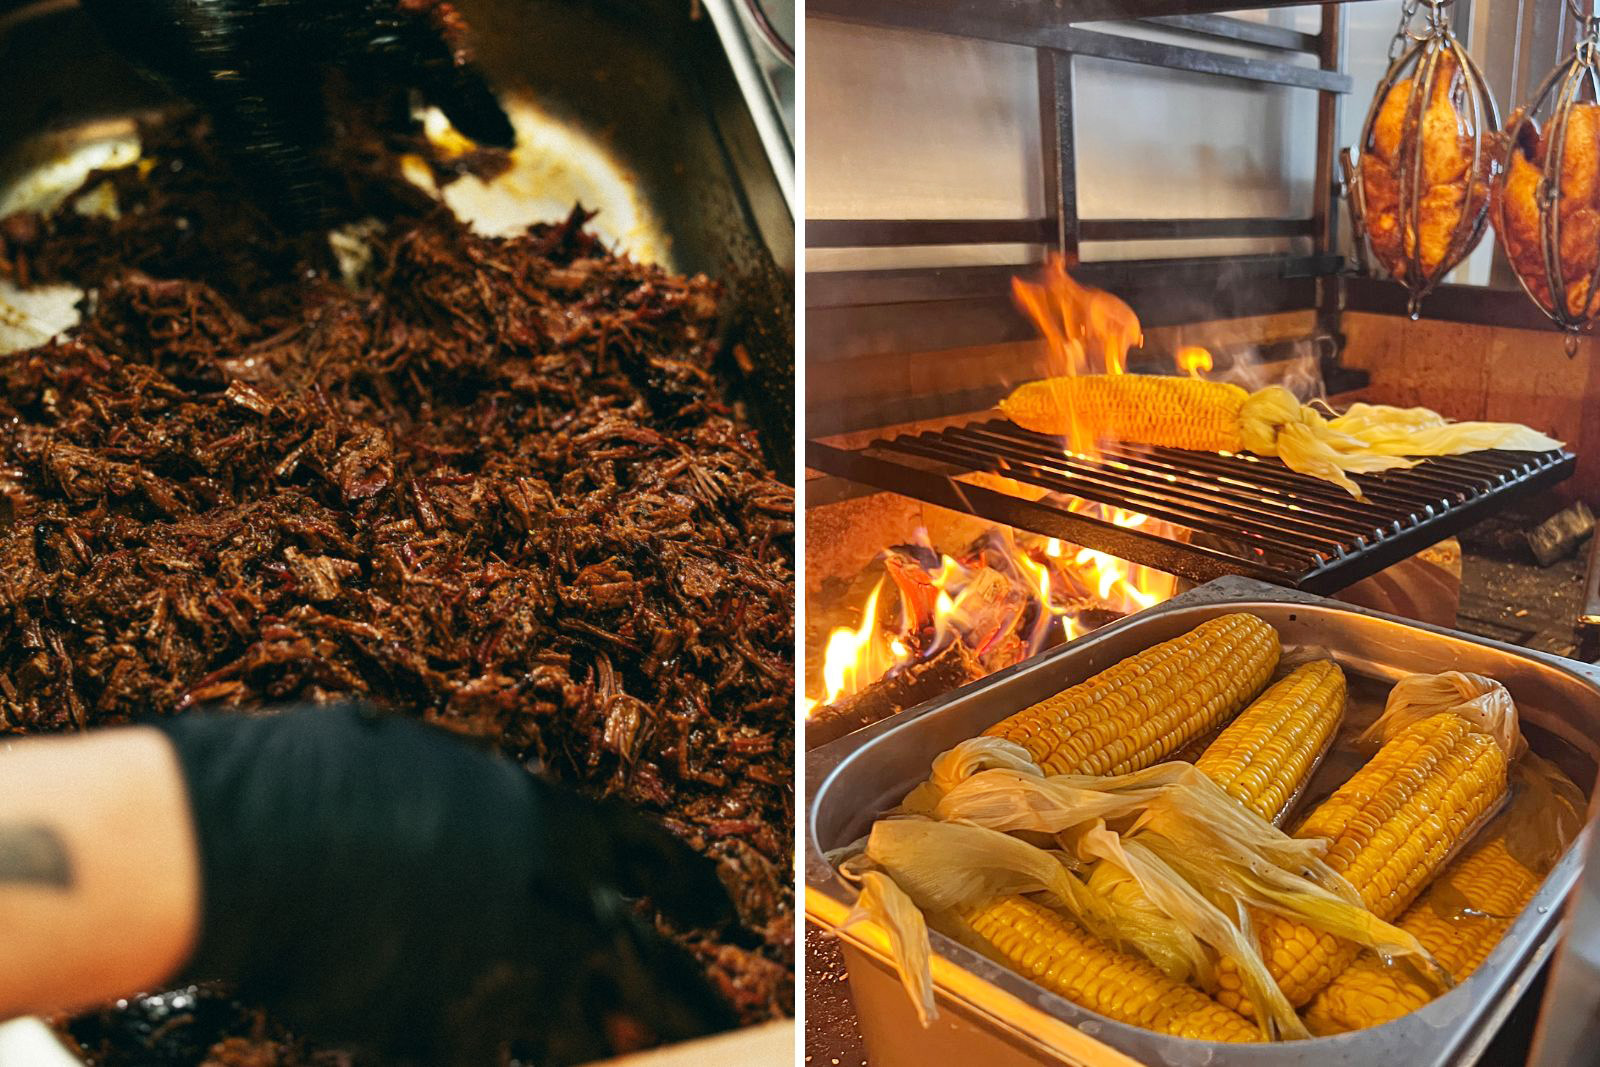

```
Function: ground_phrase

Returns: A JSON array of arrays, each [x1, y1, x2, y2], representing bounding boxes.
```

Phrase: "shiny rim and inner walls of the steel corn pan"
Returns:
[[805, 577, 1600, 1067]]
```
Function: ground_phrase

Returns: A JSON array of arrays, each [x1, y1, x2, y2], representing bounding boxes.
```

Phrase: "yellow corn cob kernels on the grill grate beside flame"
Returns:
[[1000, 374, 1250, 453]]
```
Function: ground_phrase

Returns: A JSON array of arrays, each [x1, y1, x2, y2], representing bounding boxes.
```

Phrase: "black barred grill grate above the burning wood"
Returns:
[[806, 419, 1576, 593]]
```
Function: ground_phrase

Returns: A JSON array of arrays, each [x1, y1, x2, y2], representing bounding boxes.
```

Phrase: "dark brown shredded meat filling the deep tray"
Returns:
[[0, 112, 794, 1064]]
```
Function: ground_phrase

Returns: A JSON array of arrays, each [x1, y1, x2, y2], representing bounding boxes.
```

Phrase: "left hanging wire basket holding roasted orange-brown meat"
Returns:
[[1341, 0, 1499, 318]]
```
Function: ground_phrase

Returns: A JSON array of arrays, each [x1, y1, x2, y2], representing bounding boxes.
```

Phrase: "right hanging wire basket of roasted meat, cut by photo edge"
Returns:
[[1491, 0, 1600, 342]]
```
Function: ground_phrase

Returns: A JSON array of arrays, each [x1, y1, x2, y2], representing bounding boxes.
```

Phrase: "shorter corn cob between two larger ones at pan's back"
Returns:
[[1195, 659, 1344, 822]]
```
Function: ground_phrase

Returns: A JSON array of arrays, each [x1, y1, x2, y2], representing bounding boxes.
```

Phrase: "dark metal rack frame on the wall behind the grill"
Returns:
[[806, 0, 1350, 441]]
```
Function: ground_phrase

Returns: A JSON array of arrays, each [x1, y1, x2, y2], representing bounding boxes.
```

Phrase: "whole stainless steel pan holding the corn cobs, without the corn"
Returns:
[[805, 577, 1600, 1067]]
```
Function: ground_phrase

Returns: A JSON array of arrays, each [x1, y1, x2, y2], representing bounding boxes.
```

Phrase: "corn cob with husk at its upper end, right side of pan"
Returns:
[[1218, 712, 1507, 1013]]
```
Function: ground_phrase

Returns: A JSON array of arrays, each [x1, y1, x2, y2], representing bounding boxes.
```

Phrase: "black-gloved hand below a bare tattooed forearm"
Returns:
[[150, 707, 734, 1067]]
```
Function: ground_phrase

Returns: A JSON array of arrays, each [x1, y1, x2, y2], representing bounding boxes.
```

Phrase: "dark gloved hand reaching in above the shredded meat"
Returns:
[[82, 0, 514, 227]]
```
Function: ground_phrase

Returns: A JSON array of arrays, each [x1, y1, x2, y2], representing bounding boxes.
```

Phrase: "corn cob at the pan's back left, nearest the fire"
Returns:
[[984, 613, 1278, 774]]
